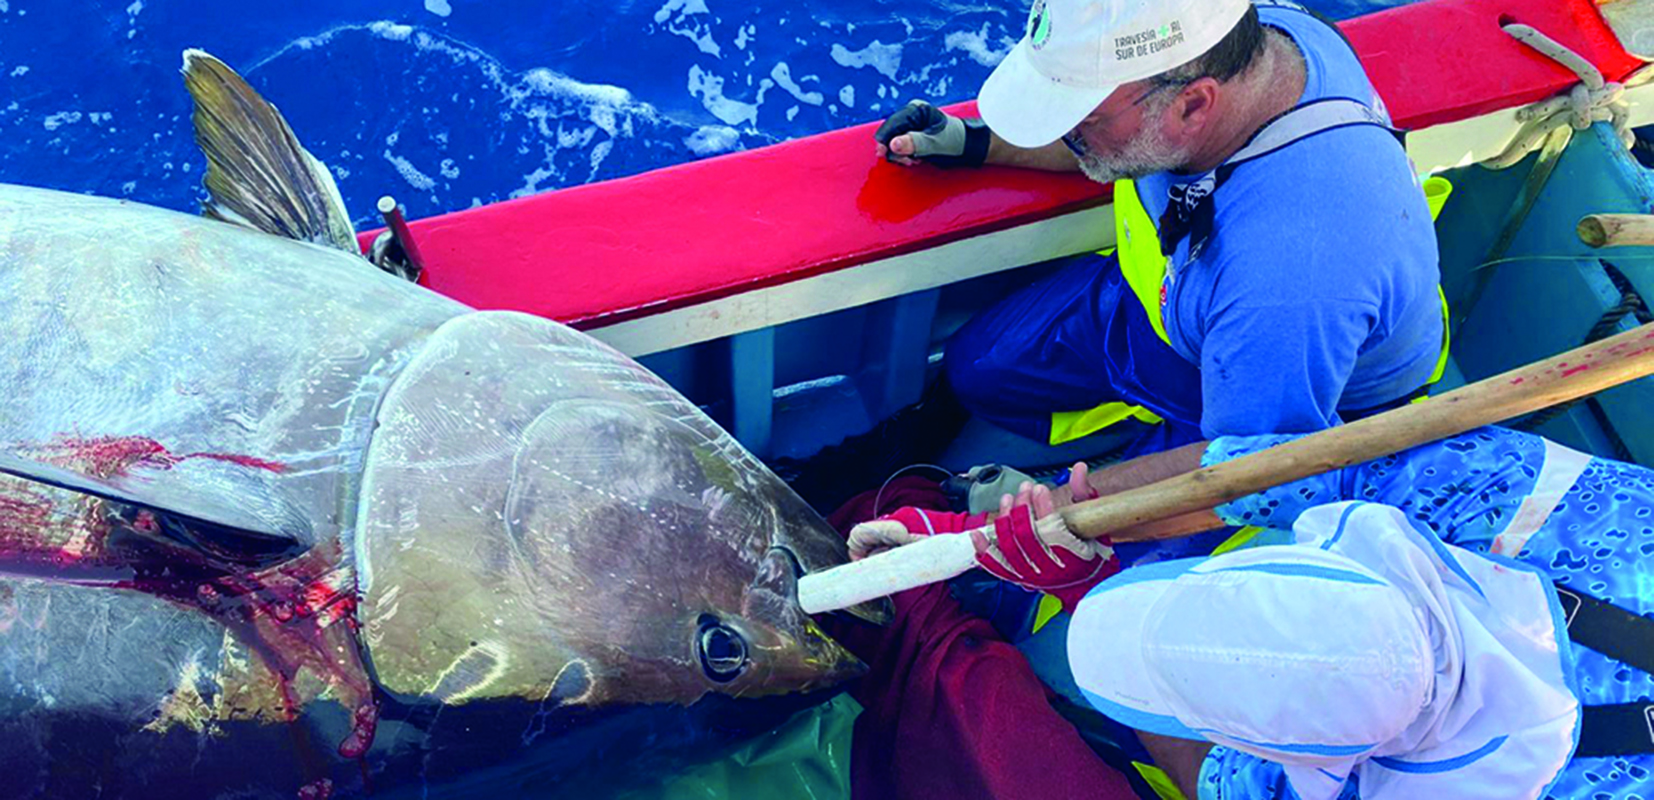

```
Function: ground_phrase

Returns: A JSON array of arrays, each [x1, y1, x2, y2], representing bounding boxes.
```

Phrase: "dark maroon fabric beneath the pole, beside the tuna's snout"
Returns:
[[829, 478, 1136, 800]]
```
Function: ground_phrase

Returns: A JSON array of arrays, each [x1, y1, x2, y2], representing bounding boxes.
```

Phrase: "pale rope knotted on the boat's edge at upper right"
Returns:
[[1484, 23, 1654, 170]]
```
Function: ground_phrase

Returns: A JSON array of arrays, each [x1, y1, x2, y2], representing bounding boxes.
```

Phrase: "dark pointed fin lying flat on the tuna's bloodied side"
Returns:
[[0, 453, 309, 564]]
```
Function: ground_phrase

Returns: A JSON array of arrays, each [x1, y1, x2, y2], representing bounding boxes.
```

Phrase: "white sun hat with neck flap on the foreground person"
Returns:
[[1068, 502, 1580, 800]]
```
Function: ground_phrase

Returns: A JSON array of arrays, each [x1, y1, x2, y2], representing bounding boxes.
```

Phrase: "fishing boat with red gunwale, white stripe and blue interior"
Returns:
[[342, 0, 1654, 797]]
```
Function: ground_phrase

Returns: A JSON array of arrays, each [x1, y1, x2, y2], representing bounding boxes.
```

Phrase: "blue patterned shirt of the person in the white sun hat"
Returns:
[[1199, 428, 1654, 800]]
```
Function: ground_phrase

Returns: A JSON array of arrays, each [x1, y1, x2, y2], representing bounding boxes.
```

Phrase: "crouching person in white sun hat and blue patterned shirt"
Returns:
[[852, 428, 1654, 800]]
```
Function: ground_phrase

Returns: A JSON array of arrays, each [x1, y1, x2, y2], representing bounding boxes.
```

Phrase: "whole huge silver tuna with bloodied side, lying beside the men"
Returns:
[[0, 53, 860, 798]]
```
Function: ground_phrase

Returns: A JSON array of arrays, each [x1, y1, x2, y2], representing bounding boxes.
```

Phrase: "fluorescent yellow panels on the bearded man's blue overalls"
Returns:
[[1050, 177, 1452, 445]]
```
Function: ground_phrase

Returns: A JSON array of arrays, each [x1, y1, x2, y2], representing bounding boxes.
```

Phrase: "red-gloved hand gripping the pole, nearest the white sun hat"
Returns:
[[971, 483, 1120, 613]]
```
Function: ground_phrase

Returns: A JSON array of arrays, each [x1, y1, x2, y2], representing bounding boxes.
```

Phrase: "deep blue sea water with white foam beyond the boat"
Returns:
[[0, 0, 1406, 226]]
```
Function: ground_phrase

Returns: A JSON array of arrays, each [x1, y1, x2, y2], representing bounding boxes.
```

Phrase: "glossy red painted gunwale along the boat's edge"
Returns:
[[361, 0, 1642, 344]]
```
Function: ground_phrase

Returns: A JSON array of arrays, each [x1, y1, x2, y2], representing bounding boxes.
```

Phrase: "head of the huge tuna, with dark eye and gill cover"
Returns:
[[354, 312, 860, 707]]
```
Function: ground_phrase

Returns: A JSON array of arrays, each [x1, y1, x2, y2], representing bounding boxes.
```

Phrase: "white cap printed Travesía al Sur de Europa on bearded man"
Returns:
[[976, 0, 1252, 147]]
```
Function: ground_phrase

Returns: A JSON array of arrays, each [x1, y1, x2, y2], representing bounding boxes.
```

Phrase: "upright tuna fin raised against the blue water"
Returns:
[[184, 50, 361, 255]]
